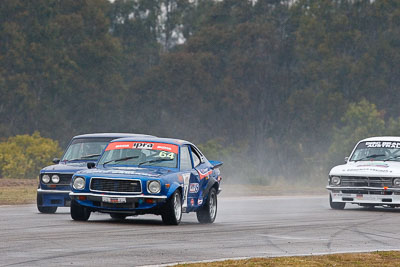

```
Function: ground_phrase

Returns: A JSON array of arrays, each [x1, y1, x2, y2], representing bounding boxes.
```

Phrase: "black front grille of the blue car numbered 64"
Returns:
[[90, 178, 142, 193]]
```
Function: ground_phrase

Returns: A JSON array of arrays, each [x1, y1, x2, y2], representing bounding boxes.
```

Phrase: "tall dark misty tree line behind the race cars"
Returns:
[[0, 0, 400, 183]]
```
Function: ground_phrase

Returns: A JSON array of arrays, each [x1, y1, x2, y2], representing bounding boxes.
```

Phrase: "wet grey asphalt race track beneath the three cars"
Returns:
[[0, 196, 400, 266]]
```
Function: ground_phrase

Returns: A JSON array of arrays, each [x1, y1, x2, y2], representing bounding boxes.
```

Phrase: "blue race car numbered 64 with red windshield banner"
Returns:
[[70, 137, 222, 225]]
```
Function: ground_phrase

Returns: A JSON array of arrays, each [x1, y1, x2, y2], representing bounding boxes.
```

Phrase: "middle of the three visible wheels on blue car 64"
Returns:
[[161, 190, 182, 225]]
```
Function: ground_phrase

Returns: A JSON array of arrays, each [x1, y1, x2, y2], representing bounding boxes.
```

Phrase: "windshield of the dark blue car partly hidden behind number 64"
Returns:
[[61, 138, 113, 161]]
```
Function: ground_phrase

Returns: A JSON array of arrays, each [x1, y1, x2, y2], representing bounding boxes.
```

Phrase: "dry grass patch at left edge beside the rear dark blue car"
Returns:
[[0, 178, 38, 205]]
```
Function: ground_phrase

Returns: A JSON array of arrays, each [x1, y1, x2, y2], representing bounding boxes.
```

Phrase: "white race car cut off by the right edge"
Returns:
[[326, 136, 400, 209]]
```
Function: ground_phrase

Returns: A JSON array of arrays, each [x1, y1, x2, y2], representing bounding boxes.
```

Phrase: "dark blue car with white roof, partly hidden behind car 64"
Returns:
[[37, 133, 152, 213]]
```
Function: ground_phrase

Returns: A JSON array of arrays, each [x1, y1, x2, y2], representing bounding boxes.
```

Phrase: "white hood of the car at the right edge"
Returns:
[[329, 161, 400, 177]]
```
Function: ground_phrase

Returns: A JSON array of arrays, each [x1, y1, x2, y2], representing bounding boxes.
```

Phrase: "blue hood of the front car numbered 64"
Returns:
[[77, 167, 173, 178]]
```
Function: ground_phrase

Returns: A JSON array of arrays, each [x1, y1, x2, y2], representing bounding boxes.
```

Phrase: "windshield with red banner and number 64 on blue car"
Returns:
[[98, 142, 178, 168]]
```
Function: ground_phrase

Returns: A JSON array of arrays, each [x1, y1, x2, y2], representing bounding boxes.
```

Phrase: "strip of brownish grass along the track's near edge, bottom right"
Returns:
[[174, 251, 400, 267]]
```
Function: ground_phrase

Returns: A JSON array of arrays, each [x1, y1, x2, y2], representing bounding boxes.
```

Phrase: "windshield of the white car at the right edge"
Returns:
[[350, 141, 400, 161]]
